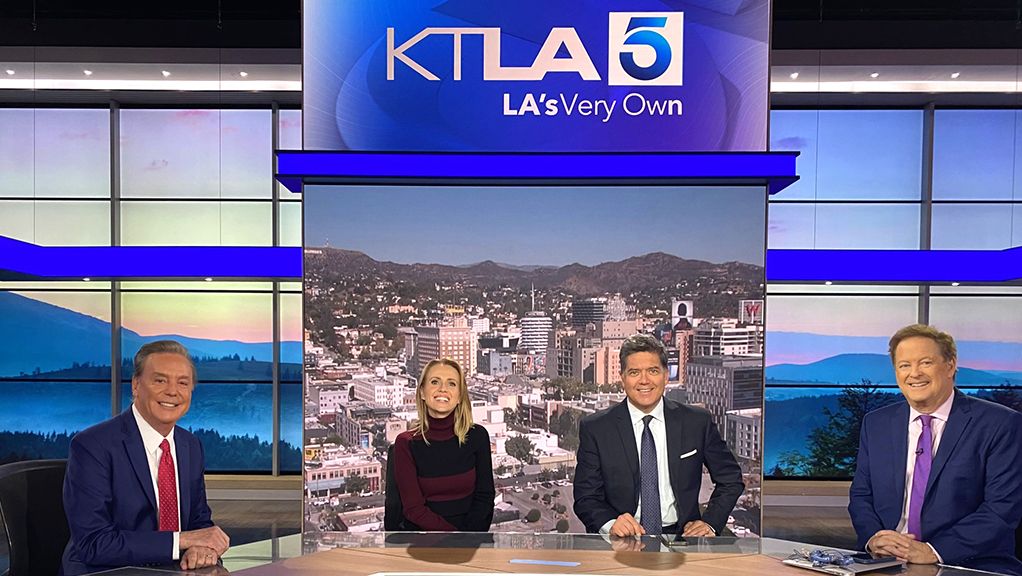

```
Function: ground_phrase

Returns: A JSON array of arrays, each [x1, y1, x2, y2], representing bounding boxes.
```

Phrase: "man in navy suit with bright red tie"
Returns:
[[61, 340, 230, 576]]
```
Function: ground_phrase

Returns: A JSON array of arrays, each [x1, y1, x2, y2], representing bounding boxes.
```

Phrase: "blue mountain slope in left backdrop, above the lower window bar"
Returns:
[[0, 292, 301, 377]]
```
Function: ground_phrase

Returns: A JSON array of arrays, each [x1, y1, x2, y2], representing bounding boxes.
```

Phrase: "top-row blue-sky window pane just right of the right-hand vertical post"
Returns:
[[933, 110, 1018, 200]]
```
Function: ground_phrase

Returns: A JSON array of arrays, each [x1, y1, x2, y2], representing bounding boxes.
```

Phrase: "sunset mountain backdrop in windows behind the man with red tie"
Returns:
[[0, 292, 301, 471]]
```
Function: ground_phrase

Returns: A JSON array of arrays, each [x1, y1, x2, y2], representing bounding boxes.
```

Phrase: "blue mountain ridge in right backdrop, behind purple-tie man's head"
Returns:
[[767, 353, 1022, 386]]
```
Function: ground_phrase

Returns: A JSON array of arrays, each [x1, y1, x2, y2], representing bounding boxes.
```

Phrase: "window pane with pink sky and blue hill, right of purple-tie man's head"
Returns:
[[930, 295, 1022, 386]]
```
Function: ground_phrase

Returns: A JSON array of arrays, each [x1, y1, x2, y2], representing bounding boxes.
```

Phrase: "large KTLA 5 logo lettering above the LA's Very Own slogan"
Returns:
[[386, 12, 684, 86]]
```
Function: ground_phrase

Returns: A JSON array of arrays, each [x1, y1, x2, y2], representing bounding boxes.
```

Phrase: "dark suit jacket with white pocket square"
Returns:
[[574, 398, 745, 534]]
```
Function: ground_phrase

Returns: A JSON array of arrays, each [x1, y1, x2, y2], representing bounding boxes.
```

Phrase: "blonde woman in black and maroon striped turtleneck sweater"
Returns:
[[385, 358, 496, 532]]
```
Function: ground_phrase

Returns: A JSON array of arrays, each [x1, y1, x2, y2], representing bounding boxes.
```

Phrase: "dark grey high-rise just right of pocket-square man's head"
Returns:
[[685, 355, 763, 434]]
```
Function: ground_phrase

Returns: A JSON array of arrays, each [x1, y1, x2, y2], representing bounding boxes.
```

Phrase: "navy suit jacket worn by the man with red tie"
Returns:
[[61, 407, 213, 575]]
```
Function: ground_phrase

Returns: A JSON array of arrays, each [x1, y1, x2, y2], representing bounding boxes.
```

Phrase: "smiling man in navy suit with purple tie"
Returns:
[[848, 324, 1022, 575]]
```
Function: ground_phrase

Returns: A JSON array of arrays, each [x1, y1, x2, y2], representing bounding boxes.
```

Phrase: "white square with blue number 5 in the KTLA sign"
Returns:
[[607, 12, 685, 86]]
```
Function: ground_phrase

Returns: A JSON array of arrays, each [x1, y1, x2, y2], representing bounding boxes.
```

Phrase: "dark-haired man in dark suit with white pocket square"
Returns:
[[574, 334, 745, 537]]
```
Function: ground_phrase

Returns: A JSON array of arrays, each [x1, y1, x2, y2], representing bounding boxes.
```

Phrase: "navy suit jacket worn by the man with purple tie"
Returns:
[[848, 389, 1022, 574]]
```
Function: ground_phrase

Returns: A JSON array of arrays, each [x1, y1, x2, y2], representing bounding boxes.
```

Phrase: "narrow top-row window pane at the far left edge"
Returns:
[[0, 108, 36, 197]]
